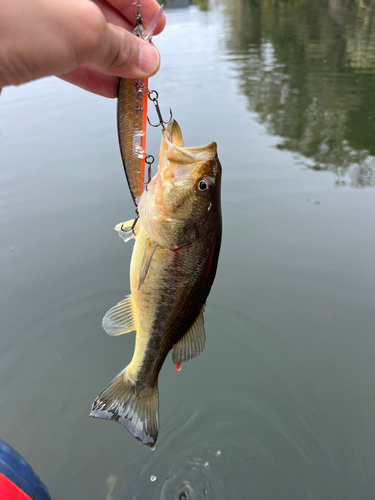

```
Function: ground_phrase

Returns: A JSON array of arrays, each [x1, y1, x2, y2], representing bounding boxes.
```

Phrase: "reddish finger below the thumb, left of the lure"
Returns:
[[59, 66, 119, 98]]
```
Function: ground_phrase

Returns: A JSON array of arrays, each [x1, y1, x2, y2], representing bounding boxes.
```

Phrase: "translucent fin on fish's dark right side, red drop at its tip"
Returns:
[[172, 306, 206, 367]]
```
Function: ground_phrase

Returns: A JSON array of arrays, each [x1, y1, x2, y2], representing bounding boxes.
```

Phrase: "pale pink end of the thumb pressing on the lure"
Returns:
[[89, 23, 160, 78]]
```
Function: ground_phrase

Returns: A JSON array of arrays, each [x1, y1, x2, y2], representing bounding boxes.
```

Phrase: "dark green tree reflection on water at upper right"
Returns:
[[222, 0, 375, 187]]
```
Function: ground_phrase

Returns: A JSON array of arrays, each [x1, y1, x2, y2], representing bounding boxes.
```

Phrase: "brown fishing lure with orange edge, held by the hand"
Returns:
[[117, 4, 163, 205]]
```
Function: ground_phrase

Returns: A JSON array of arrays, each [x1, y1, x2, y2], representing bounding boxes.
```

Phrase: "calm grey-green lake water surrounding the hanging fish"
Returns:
[[0, 0, 375, 500]]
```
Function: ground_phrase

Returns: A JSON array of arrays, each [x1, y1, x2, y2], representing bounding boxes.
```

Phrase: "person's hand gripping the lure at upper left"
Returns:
[[0, 0, 165, 97]]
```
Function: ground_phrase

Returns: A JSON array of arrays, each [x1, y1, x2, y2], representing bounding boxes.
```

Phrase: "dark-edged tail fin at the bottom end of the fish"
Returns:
[[90, 369, 159, 447]]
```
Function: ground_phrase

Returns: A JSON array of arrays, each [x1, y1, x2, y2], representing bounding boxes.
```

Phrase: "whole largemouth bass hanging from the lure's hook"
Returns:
[[90, 120, 221, 447]]
